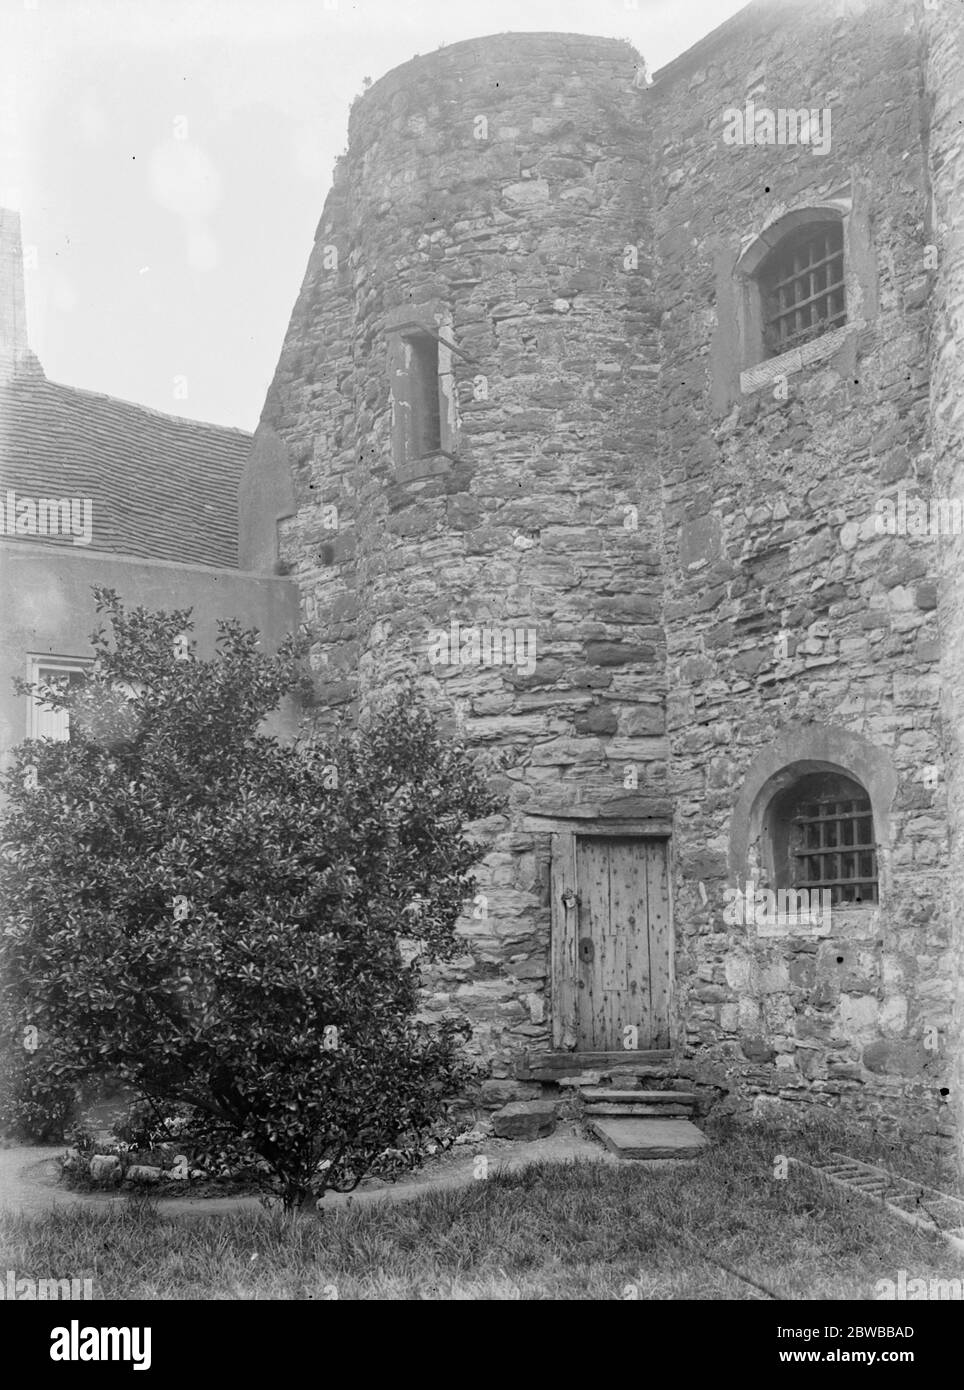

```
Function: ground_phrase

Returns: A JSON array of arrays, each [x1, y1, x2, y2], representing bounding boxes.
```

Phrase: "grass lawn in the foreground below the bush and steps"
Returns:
[[0, 1126, 964, 1300]]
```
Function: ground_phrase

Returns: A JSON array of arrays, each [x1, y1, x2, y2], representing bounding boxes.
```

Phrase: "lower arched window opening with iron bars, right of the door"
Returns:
[[765, 771, 878, 906]]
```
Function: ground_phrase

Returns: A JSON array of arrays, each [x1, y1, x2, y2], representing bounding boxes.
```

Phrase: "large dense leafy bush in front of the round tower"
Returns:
[[0, 589, 497, 1207]]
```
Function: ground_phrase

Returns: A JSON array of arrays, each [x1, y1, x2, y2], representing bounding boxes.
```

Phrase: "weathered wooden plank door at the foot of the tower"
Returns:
[[570, 835, 671, 1052]]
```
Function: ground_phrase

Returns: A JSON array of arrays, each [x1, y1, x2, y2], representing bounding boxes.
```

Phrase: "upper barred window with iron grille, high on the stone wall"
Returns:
[[760, 221, 847, 357]]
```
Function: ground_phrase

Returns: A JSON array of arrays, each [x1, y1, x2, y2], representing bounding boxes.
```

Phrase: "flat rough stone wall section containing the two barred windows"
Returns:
[[649, 0, 954, 1133]]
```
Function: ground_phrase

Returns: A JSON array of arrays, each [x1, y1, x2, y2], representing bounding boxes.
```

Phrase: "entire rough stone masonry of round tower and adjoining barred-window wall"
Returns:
[[242, 0, 964, 1173]]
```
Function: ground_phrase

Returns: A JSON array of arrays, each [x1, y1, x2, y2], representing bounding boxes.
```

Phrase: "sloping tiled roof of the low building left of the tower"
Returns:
[[0, 368, 251, 567]]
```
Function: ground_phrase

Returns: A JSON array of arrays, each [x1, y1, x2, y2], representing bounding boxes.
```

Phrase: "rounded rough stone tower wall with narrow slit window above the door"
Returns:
[[255, 35, 668, 1098]]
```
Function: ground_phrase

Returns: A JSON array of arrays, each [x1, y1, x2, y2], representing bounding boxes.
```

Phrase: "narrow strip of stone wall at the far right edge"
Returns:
[[918, 3, 964, 1169]]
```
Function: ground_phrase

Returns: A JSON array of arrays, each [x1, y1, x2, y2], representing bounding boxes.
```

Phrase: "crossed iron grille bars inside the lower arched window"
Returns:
[[790, 796, 878, 906]]
